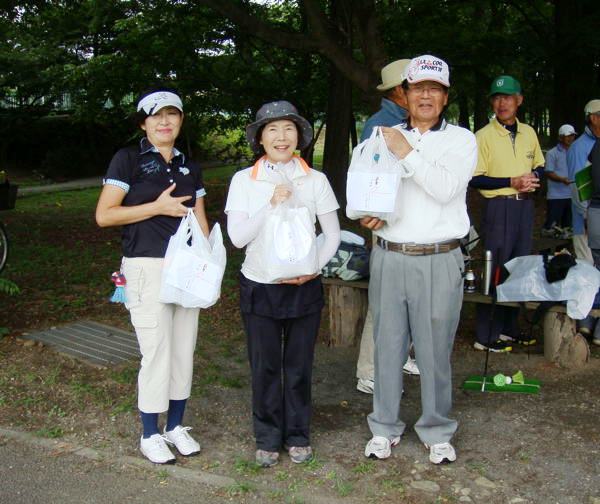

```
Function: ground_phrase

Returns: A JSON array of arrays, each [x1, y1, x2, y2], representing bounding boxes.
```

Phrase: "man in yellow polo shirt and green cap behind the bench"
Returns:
[[470, 75, 544, 352]]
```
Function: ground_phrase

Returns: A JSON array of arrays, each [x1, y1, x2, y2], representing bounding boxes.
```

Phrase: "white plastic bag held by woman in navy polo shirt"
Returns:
[[159, 209, 227, 308]]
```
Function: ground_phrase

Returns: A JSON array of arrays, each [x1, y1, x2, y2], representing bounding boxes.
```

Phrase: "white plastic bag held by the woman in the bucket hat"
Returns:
[[256, 175, 319, 282]]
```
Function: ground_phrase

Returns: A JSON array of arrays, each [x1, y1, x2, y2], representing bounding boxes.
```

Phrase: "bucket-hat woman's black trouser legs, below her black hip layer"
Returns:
[[242, 311, 321, 451]]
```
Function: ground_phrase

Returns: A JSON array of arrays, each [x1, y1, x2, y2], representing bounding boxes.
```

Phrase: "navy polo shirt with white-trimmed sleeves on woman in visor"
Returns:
[[104, 138, 206, 257]]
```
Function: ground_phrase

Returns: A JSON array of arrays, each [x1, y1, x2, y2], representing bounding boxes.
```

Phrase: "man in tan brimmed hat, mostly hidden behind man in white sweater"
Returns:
[[356, 59, 419, 394]]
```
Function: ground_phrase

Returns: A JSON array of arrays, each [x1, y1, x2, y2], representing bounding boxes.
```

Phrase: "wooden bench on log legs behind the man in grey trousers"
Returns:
[[323, 278, 600, 367]]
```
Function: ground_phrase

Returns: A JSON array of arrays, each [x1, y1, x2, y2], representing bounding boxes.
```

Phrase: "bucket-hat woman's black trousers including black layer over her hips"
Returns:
[[240, 275, 324, 451]]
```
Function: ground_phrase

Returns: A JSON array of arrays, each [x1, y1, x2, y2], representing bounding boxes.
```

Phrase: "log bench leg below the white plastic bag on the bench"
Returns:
[[544, 312, 590, 368]]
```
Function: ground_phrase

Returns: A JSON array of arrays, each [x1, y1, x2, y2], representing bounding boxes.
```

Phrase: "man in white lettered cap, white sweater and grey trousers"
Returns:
[[348, 55, 477, 464]]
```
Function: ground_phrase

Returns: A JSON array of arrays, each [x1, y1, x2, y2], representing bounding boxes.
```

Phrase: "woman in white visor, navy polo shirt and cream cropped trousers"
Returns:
[[96, 89, 208, 464]]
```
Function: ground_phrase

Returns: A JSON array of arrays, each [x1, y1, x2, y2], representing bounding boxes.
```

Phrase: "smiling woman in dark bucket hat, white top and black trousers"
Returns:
[[225, 101, 340, 467]]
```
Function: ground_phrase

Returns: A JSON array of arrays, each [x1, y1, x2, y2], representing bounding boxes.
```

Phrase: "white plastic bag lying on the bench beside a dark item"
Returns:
[[496, 255, 600, 320]]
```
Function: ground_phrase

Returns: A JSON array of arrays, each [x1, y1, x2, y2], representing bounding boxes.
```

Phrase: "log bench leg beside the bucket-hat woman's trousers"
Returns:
[[328, 283, 369, 347]]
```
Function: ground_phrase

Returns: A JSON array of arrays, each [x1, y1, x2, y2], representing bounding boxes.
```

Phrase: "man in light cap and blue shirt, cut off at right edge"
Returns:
[[567, 99, 600, 338]]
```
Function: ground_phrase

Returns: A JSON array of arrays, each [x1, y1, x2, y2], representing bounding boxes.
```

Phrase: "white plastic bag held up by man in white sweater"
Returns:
[[346, 128, 412, 222]]
